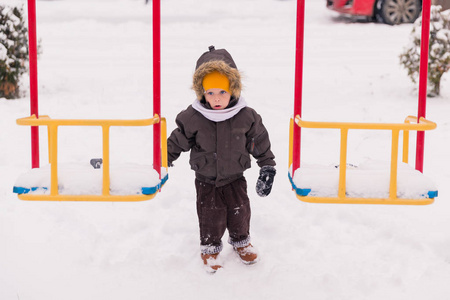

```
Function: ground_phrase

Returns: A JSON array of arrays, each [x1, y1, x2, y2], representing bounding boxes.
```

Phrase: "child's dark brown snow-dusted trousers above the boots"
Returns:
[[195, 177, 251, 254]]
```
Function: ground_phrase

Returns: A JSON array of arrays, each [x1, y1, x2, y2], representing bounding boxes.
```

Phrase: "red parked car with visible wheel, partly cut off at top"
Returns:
[[327, 0, 422, 25]]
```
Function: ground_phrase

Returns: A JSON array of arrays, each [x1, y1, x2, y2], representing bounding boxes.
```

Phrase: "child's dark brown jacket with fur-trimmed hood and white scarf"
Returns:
[[167, 46, 275, 187]]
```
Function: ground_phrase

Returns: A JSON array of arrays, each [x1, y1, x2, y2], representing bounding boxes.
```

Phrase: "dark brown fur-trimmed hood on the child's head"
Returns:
[[192, 46, 242, 100]]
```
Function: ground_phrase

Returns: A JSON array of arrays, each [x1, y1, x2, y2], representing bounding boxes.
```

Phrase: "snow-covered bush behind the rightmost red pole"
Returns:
[[400, 5, 450, 96]]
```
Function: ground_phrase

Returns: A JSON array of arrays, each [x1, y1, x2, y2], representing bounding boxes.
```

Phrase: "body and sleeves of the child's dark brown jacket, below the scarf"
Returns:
[[167, 106, 275, 187]]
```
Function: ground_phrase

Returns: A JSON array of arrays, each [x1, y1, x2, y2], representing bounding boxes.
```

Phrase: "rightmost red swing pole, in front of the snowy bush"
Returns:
[[416, 0, 431, 172]]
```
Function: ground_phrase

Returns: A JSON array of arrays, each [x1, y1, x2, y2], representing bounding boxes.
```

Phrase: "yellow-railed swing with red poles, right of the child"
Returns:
[[288, 0, 438, 205]]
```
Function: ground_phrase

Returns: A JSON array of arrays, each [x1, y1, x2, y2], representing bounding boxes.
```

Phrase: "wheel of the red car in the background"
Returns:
[[377, 0, 422, 25]]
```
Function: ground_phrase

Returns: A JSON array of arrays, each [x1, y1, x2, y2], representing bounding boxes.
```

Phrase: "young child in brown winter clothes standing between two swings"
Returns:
[[167, 46, 276, 272]]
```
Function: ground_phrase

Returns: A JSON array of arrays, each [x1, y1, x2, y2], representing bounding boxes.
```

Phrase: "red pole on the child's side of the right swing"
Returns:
[[292, 0, 305, 177]]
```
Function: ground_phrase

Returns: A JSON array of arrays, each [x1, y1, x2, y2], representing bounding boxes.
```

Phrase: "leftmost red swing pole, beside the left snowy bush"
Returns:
[[28, 0, 39, 168]]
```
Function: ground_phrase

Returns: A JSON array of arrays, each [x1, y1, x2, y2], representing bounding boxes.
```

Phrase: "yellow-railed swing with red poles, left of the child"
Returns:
[[13, 0, 168, 202]]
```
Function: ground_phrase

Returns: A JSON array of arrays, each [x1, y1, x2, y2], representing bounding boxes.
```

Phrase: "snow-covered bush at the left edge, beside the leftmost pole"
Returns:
[[0, 4, 28, 99]]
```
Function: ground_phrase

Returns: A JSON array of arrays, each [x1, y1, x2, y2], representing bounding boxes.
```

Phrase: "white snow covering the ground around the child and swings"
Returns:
[[0, 0, 450, 300]]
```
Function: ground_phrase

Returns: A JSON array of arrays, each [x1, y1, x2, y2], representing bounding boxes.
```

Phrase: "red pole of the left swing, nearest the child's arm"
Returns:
[[152, 0, 161, 177]]
